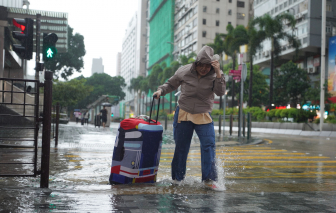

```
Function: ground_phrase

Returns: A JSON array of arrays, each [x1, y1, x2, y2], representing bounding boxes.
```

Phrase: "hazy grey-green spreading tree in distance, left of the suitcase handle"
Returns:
[[78, 73, 126, 108]]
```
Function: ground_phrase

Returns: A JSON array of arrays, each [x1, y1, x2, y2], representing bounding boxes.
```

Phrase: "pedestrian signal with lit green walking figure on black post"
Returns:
[[43, 33, 58, 61]]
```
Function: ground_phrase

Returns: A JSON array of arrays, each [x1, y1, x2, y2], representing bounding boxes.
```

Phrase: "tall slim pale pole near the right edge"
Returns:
[[320, 0, 327, 132]]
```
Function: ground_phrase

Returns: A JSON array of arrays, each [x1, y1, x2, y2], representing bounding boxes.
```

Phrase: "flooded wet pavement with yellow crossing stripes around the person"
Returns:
[[0, 123, 336, 213]]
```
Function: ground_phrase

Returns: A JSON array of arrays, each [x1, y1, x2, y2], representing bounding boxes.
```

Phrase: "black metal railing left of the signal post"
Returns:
[[0, 78, 40, 177]]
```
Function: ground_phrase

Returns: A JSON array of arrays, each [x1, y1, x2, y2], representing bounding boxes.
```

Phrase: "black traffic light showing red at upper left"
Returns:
[[12, 18, 34, 60]]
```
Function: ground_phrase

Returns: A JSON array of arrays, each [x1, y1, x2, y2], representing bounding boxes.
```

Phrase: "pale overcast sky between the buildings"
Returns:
[[29, 0, 138, 78]]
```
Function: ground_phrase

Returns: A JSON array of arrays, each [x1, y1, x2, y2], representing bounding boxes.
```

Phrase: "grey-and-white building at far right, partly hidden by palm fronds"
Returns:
[[254, 0, 336, 102]]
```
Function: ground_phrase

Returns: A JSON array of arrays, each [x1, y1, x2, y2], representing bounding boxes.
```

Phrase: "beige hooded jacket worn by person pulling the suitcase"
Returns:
[[159, 46, 226, 114]]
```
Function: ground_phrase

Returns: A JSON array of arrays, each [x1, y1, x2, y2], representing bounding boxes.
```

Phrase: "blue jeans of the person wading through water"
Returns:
[[171, 107, 217, 181]]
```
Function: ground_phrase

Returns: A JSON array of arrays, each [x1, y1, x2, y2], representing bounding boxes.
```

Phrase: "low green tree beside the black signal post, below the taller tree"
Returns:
[[52, 79, 93, 111]]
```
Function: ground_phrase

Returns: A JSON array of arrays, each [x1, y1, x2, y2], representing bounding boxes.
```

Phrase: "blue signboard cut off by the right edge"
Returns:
[[328, 36, 336, 97]]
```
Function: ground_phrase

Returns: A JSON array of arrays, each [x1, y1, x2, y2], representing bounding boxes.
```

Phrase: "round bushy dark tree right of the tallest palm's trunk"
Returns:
[[274, 61, 310, 107]]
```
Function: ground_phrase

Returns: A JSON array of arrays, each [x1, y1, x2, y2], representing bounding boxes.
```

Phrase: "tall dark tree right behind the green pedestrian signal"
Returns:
[[44, 25, 86, 80]]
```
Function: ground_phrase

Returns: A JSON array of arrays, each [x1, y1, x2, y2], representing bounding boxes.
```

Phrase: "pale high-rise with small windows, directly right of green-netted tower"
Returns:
[[173, 0, 252, 60]]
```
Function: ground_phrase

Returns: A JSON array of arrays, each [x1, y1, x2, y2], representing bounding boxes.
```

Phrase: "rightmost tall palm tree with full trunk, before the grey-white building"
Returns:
[[252, 13, 300, 108]]
